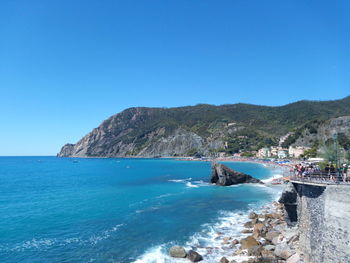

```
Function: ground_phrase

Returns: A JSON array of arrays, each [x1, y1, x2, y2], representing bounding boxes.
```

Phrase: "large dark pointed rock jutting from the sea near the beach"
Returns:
[[211, 163, 263, 186]]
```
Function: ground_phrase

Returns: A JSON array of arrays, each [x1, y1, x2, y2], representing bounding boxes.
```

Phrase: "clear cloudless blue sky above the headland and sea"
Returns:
[[0, 0, 350, 155]]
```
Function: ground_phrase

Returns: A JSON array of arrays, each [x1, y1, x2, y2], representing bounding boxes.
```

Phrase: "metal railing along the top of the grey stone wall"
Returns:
[[290, 171, 350, 185]]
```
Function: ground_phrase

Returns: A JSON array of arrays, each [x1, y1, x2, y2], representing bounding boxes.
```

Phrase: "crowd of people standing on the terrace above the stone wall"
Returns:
[[294, 163, 350, 182]]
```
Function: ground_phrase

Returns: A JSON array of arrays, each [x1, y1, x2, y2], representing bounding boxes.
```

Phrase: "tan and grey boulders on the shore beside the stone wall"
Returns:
[[169, 197, 303, 263]]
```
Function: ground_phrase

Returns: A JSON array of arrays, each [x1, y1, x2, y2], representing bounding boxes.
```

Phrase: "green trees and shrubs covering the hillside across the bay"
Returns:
[[60, 96, 350, 156]]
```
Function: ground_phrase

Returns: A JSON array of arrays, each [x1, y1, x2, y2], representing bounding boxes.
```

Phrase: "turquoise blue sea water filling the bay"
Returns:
[[0, 157, 277, 263]]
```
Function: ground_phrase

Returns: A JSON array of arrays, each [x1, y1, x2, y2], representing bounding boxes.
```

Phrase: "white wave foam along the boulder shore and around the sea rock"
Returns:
[[134, 165, 282, 263]]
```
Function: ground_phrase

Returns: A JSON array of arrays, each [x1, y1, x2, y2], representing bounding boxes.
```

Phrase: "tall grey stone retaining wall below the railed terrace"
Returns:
[[294, 183, 350, 263]]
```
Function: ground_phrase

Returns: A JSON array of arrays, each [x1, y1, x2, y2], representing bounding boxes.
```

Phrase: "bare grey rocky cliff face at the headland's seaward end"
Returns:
[[58, 108, 223, 157]]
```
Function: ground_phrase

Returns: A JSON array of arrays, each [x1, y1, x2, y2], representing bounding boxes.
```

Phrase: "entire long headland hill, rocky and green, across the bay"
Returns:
[[58, 97, 350, 157]]
